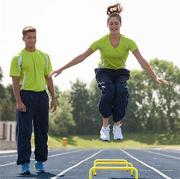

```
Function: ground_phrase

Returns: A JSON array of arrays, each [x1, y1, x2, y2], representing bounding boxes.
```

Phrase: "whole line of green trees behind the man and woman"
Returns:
[[0, 59, 180, 136]]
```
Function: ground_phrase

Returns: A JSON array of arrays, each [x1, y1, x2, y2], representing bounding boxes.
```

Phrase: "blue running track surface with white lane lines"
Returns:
[[0, 149, 180, 179]]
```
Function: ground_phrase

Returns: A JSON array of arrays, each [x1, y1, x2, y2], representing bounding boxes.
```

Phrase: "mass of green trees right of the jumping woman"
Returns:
[[125, 59, 180, 132]]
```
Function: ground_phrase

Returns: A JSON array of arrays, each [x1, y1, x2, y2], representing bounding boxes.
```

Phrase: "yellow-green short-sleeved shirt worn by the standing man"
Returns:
[[10, 49, 52, 91]]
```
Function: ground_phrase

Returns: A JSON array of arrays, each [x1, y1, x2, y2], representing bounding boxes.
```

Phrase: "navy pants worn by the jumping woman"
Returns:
[[95, 68, 130, 122]]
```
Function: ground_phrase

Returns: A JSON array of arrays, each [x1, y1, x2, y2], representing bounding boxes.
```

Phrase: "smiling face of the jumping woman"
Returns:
[[107, 17, 121, 34]]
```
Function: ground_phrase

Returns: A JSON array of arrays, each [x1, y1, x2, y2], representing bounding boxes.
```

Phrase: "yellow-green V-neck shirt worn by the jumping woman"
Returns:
[[90, 34, 138, 69]]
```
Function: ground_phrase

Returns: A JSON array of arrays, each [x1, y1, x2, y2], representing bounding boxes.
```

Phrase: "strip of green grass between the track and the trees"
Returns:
[[43, 133, 180, 149]]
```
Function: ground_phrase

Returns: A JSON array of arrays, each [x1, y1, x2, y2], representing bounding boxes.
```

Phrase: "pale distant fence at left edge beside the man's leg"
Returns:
[[0, 121, 16, 141]]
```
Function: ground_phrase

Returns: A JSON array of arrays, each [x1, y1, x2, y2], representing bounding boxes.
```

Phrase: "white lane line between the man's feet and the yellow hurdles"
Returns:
[[51, 149, 103, 179]]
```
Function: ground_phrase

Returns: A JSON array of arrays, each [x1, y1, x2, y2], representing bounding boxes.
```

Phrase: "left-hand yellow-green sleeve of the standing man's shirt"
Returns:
[[9, 56, 21, 77]]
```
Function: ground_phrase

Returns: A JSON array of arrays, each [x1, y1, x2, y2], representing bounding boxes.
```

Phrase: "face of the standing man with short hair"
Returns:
[[23, 32, 36, 49]]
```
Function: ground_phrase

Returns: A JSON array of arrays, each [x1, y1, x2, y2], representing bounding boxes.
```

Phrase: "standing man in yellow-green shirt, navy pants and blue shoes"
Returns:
[[10, 26, 57, 174]]
